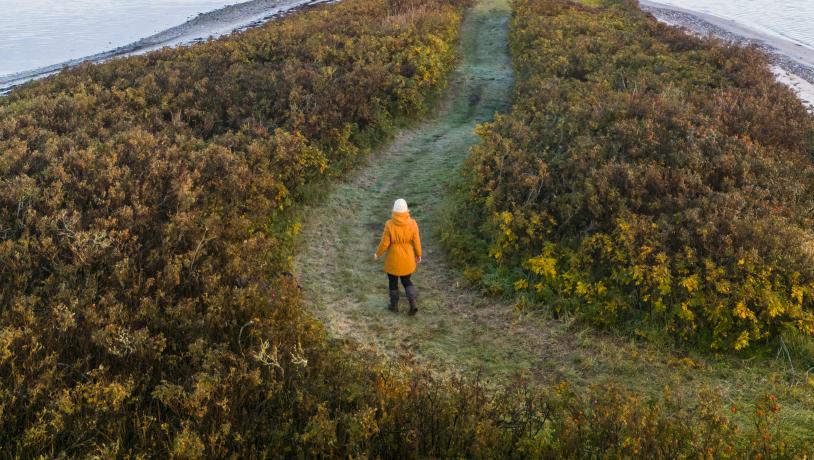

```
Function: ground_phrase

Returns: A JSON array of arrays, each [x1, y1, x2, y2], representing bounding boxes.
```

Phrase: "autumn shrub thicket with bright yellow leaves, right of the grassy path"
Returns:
[[448, 0, 814, 350]]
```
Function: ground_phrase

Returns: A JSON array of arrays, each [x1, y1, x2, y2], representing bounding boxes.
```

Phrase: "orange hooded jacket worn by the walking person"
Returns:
[[376, 212, 421, 276]]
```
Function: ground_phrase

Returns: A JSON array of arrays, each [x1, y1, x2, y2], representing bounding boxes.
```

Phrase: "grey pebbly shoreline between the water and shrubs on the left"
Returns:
[[0, 0, 337, 95]]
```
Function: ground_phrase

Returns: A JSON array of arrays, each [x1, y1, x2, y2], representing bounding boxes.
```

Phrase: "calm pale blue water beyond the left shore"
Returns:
[[0, 0, 242, 76]]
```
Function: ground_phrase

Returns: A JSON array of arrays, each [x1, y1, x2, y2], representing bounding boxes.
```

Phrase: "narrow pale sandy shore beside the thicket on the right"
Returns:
[[639, 0, 814, 112]]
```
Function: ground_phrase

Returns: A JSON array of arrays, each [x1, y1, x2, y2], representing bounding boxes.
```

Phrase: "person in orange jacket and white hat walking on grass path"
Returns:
[[373, 198, 421, 316]]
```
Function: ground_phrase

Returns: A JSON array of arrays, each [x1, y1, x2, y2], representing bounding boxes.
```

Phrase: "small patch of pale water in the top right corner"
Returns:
[[654, 0, 814, 49]]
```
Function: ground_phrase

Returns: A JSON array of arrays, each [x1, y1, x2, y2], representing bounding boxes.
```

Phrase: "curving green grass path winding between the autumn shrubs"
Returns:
[[295, 0, 814, 435]]
